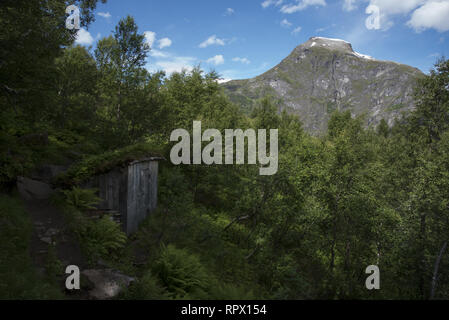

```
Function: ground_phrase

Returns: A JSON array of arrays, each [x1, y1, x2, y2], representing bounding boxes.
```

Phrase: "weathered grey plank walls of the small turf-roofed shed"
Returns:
[[89, 157, 164, 235]]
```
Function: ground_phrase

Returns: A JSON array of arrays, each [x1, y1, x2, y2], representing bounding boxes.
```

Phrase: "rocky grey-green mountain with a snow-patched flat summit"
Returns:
[[222, 37, 423, 133]]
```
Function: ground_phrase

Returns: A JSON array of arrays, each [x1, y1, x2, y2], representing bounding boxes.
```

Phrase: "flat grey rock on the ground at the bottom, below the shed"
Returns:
[[82, 269, 134, 300]]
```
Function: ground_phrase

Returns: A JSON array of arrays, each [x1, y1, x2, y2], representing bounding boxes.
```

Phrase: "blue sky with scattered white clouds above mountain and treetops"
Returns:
[[77, 0, 449, 79]]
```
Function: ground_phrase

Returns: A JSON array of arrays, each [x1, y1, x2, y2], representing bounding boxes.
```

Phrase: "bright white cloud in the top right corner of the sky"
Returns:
[[407, 0, 449, 32]]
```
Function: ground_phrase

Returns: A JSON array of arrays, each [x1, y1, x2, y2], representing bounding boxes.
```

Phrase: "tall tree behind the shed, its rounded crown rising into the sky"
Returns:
[[95, 16, 150, 146]]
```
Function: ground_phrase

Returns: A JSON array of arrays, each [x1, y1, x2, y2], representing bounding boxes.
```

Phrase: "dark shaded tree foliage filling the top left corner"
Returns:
[[0, 0, 106, 127]]
